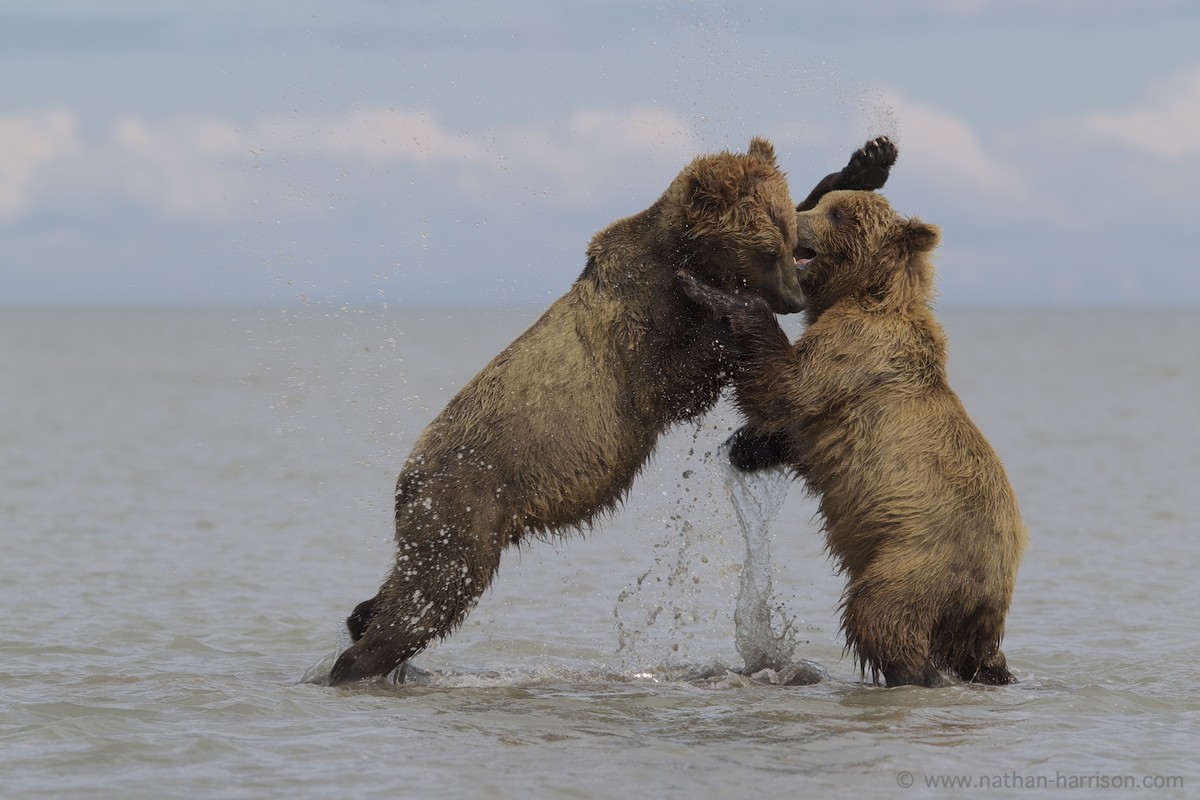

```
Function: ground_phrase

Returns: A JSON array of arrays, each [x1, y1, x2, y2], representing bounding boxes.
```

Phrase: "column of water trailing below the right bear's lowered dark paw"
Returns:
[[718, 443, 824, 684]]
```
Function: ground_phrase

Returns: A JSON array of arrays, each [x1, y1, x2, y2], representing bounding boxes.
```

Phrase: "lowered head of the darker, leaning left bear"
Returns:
[[665, 138, 804, 314]]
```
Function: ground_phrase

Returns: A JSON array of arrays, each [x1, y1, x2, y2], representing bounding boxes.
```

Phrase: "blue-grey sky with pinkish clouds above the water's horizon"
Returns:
[[0, 0, 1200, 308]]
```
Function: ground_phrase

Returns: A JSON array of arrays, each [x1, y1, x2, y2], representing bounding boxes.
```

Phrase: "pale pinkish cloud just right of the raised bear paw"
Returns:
[[881, 90, 1028, 201]]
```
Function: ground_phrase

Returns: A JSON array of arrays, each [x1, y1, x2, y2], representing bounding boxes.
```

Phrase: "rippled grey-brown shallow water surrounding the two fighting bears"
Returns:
[[0, 309, 1200, 798]]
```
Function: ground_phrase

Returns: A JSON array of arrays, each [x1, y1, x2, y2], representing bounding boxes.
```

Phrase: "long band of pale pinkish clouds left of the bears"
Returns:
[[0, 107, 698, 218]]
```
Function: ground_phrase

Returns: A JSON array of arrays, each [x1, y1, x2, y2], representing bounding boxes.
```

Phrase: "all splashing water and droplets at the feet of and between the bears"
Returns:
[[301, 412, 827, 687]]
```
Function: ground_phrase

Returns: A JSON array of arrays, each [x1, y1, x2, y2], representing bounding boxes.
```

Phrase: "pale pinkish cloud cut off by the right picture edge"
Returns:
[[1073, 68, 1200, 161]]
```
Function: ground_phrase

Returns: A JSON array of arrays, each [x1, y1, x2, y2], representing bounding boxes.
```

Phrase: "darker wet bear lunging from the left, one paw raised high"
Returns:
[[330, 138, 896, 685]]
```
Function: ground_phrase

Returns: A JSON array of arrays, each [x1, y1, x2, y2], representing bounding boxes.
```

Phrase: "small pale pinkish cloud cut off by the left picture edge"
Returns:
[[0, 109, 83, 219]]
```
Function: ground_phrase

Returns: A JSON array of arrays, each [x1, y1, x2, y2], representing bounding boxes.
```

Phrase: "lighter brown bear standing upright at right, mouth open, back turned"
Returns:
[[679, 191, 1026, 686]]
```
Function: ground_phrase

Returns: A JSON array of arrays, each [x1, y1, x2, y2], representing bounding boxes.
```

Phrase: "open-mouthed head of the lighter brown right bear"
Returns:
[[796, 191, 941, 321]]
